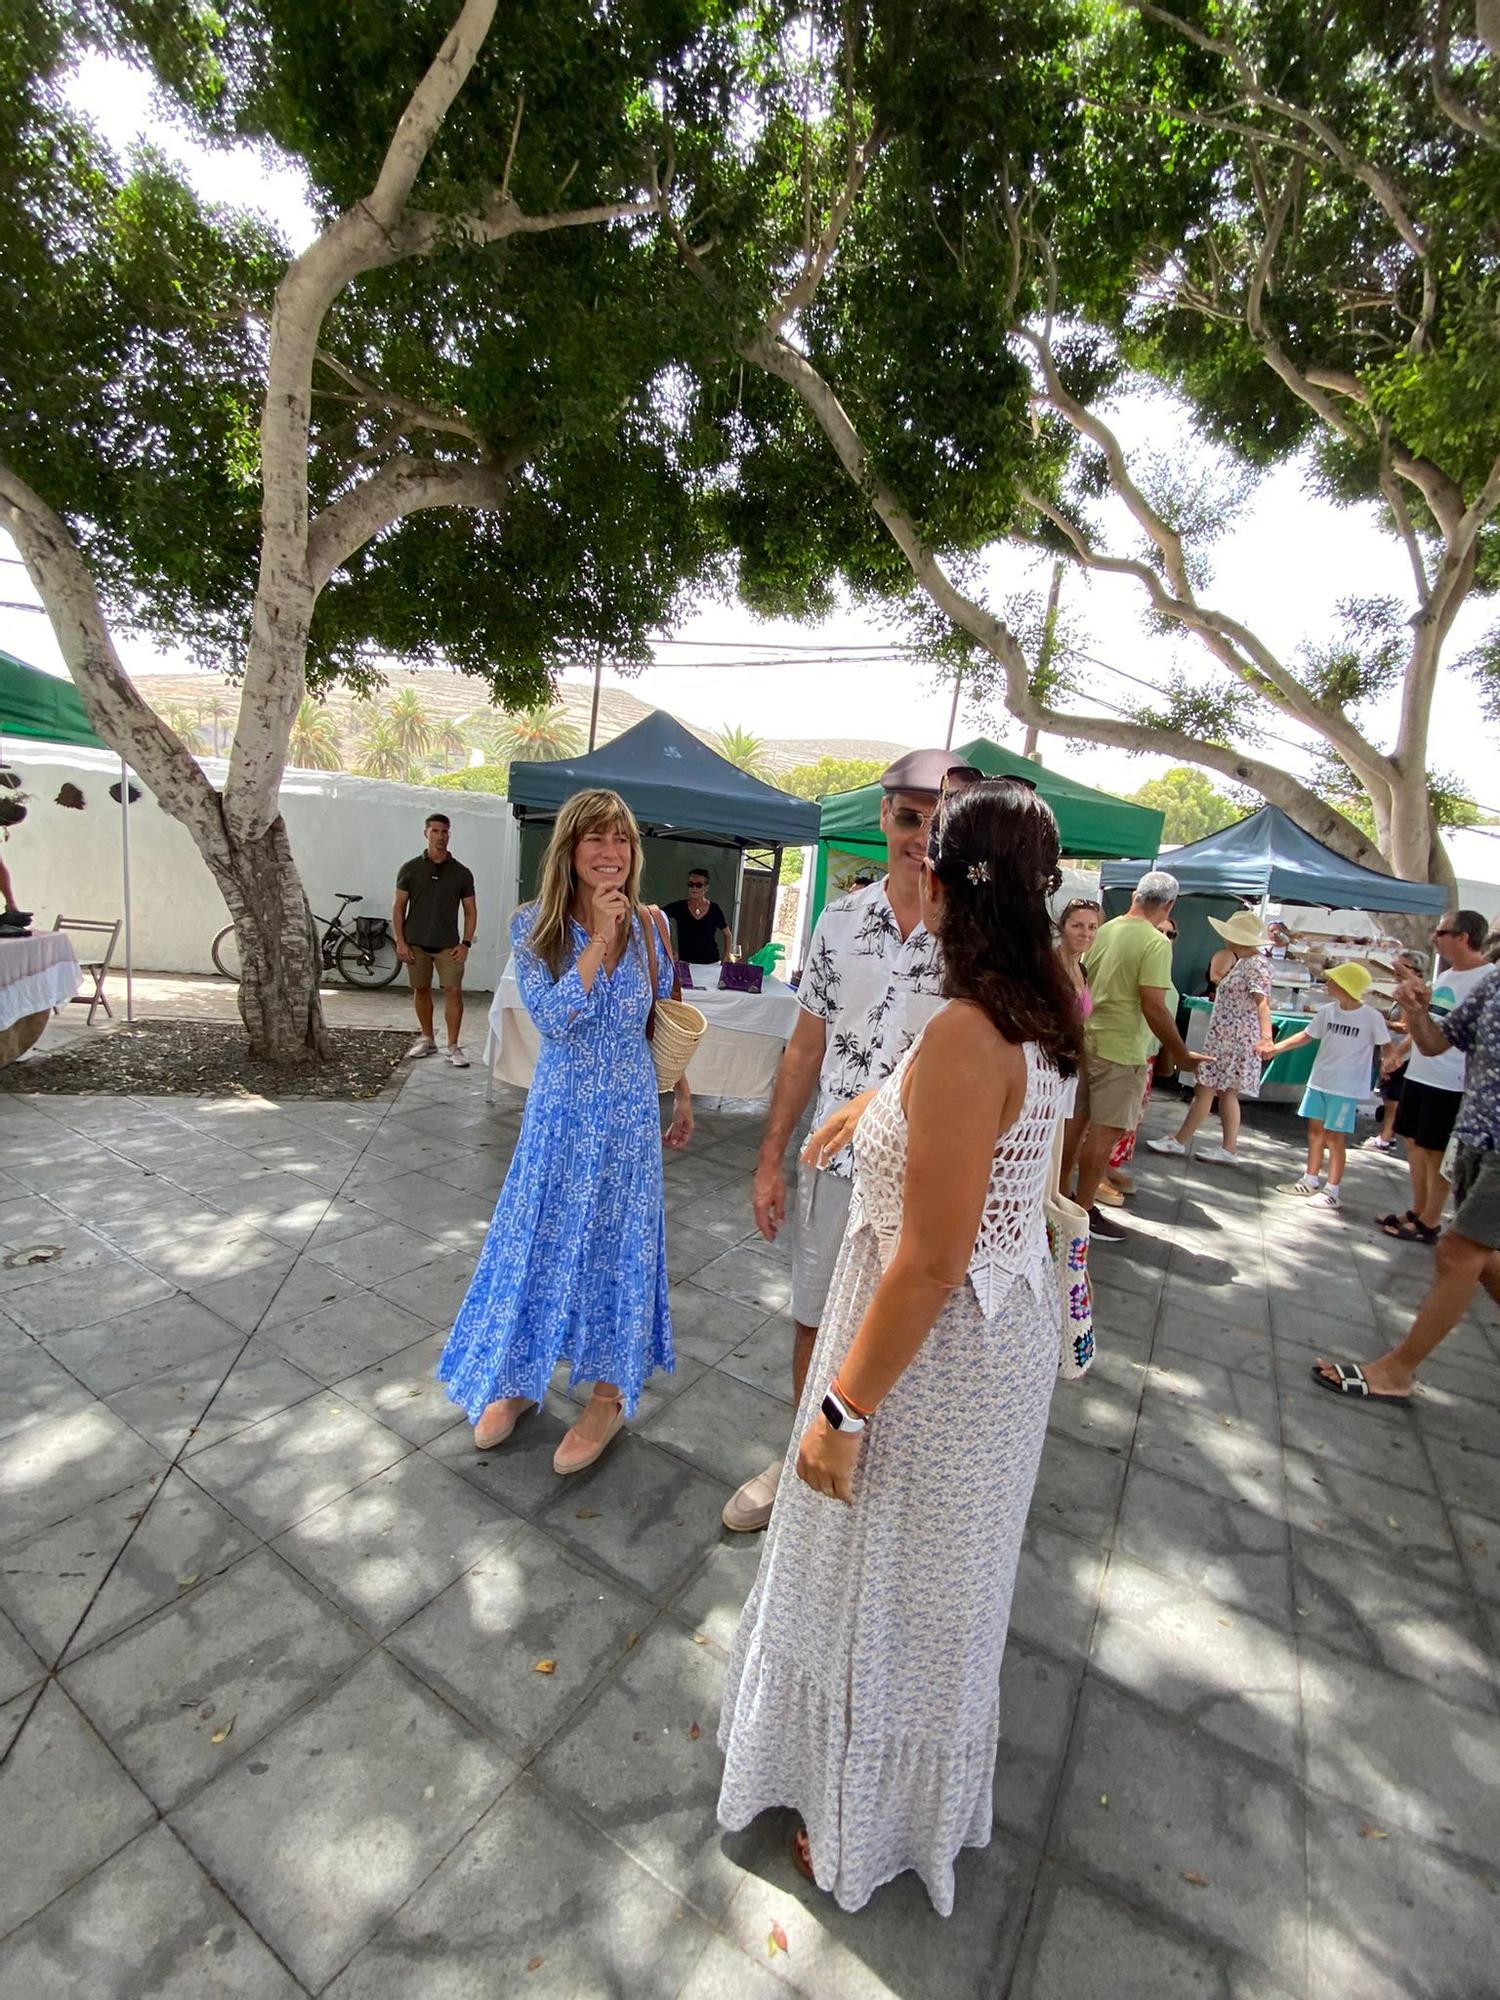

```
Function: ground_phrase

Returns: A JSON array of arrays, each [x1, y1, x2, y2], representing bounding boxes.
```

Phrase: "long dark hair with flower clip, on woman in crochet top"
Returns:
[[928, 778, 1082, 1076]]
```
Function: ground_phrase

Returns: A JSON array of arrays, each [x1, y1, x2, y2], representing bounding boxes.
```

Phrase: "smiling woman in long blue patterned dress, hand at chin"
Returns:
[[438, 792, 692, 1472]]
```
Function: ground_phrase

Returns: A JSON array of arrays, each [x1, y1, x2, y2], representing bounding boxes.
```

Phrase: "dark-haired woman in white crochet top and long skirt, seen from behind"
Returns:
[[718, 782, 1080, 1916]]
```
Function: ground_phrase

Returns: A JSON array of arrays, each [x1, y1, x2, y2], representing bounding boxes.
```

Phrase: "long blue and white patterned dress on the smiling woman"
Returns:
[[438, 906, 674, 1424]]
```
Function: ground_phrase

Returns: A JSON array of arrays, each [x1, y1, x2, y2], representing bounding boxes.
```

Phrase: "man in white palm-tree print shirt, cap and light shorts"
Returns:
[[724, 750, 984, 1534]]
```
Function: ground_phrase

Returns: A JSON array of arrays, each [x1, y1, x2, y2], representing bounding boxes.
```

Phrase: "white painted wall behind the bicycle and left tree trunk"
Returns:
[[0, 738, 520, 992]]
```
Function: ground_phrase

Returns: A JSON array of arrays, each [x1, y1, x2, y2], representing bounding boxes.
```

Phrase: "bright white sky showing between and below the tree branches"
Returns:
[[0, 60, 1500, 812]]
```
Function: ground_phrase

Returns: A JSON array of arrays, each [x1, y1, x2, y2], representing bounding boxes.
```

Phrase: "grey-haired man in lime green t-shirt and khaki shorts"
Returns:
[[1074, 868, 1204, 1242]]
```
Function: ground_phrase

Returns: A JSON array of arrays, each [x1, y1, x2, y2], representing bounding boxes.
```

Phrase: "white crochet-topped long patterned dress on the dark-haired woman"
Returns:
[[718, 1044, 1062, 1916]]
